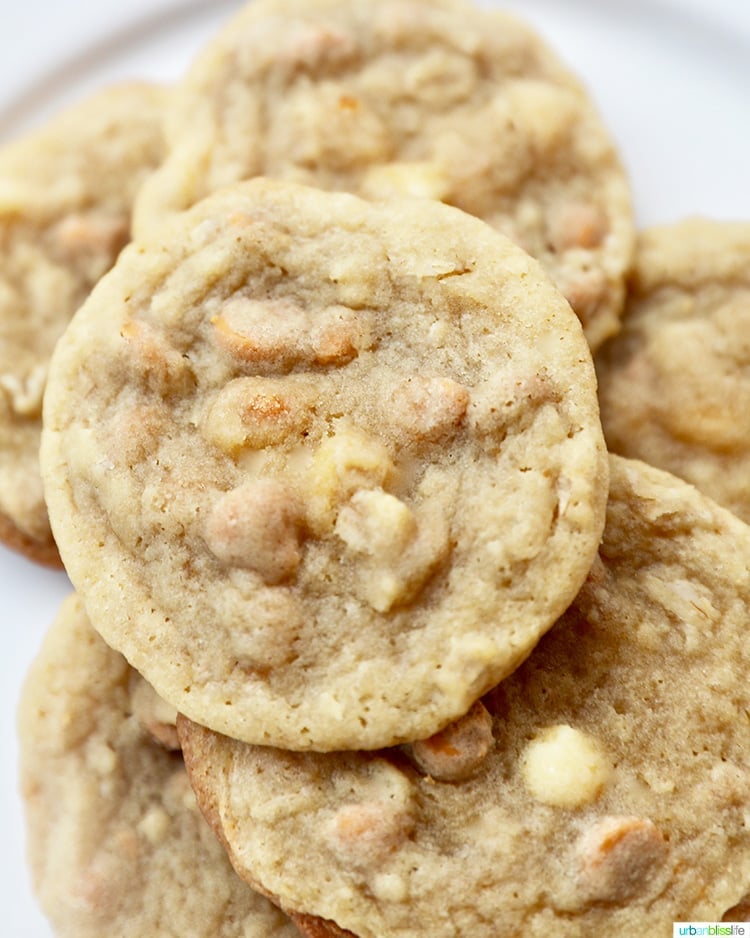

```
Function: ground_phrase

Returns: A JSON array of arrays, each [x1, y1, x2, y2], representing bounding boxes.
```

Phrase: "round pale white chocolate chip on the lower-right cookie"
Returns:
[[522, 724, 611, 808]]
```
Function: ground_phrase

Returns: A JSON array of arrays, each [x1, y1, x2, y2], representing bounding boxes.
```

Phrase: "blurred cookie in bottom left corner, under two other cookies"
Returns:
[[18, 596, 298, 938]]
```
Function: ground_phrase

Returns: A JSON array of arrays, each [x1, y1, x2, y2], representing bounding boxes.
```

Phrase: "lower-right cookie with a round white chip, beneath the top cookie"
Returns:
[[178, 457, 750, 938]]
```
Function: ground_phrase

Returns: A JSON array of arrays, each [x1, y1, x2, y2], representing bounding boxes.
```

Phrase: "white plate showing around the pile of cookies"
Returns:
[[0, 0, 750, 938]]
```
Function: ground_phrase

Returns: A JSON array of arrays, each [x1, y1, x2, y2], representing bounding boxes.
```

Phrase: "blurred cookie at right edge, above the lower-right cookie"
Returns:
[[596, 218, 750, 521]]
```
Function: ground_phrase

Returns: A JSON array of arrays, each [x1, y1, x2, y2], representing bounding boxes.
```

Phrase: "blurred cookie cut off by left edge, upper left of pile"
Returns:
[[0, 84, 166, 566]]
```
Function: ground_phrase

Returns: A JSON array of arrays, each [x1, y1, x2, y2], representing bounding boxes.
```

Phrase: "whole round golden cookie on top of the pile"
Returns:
[[42, 179, 608, 750]]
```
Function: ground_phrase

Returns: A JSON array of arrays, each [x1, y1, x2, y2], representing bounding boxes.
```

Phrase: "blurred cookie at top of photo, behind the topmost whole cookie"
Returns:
[[136, 0, 633, 348]]
